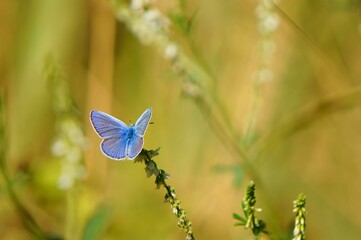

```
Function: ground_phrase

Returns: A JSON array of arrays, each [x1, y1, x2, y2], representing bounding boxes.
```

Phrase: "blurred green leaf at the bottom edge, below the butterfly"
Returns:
[[82, 205, 111, 240]]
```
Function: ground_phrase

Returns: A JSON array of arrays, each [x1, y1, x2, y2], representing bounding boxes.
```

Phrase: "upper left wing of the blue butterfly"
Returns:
[[90, 110, 128, 138]]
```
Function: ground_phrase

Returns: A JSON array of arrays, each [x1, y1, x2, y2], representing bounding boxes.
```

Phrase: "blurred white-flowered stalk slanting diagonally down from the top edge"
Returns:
[[110, 0, 261, 183]]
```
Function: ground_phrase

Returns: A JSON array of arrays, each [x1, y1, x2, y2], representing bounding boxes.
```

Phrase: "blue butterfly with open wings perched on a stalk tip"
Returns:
[[90, 108, 152, 160]]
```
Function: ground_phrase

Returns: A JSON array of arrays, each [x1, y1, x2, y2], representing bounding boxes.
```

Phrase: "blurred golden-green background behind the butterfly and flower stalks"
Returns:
[[0, 0, 361, 240]]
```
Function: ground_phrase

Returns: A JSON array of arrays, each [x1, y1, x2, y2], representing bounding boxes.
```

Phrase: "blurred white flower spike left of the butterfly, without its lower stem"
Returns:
[[46, 59, 87, 190]]
